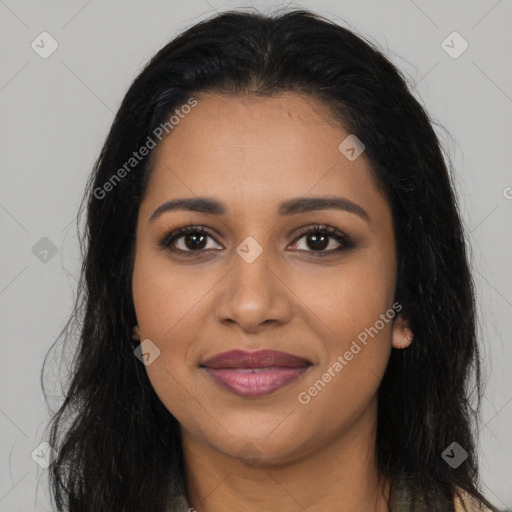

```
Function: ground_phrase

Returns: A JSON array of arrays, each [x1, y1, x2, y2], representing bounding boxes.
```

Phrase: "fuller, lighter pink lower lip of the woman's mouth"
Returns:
[[205, 366, 309, 397]]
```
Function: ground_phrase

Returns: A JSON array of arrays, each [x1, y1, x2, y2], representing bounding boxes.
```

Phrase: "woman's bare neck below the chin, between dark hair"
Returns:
[[182, 401, 388, 512]]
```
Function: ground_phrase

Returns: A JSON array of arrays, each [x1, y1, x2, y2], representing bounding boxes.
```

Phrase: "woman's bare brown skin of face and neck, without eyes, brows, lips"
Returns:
[[132, 93, 411, 512]]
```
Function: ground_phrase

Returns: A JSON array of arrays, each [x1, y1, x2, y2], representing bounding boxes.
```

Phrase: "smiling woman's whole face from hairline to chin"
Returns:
[[133, 93, 412, 463]]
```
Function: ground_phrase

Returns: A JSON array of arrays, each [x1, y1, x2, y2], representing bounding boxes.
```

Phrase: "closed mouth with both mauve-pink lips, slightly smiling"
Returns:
[[200, 350, 312, 397]]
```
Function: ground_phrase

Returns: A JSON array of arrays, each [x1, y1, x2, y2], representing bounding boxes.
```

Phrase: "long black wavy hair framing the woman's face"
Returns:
[[43, 10, 498, 512]]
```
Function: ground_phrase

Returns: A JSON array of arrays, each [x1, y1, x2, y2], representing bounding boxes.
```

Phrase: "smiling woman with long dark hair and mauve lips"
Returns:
[[43, 11, 500, 512]]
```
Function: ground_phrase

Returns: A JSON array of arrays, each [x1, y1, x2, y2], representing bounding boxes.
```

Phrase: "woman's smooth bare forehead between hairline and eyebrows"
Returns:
[[142, 93, 382, 218]]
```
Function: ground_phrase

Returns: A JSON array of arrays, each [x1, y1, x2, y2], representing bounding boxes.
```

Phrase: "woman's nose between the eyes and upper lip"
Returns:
[[215, 243, 294, 333]]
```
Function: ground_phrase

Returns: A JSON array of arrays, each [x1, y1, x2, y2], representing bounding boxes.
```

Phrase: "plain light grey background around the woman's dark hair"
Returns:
[[0, 0, 512, 512]]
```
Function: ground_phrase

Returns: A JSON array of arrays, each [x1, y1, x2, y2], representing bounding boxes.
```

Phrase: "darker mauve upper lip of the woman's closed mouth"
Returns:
[[201, 350, 311, 369]]
